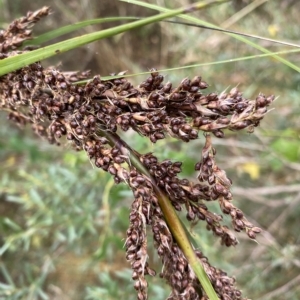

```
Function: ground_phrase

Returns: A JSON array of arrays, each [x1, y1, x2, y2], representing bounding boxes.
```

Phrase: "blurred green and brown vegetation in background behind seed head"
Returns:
[[0, 0, 300, 300]]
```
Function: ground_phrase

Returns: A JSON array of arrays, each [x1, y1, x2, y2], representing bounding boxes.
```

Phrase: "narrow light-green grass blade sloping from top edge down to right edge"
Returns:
[[119, 0, 300, 72]]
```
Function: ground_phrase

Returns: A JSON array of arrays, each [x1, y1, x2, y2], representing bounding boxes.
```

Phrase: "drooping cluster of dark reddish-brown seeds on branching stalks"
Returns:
[[0, 7, 274, 300]]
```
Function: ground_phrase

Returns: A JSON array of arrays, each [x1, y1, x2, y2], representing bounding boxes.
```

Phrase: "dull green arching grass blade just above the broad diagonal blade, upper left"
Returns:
[[23, 17, 138, 46]]
